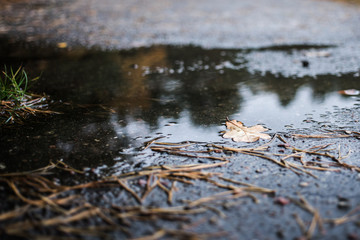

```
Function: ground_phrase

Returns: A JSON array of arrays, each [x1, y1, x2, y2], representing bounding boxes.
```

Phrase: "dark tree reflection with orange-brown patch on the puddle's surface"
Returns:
[[2, 42, 360, 172]]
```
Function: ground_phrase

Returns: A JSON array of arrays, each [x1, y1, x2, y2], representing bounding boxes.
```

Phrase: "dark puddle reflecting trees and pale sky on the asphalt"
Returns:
[[1, 42, 360, 174]]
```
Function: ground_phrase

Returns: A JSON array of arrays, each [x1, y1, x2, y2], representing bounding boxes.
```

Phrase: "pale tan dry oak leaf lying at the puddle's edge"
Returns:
[[223, 120, 271, 142]]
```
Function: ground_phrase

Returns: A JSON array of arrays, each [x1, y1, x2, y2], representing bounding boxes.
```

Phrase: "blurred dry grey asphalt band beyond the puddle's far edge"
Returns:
[[0, 0, 360, 48]]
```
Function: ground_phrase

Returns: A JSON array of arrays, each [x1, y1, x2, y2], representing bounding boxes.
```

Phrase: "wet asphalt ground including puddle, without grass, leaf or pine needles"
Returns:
[[0, 0, 360, 239]]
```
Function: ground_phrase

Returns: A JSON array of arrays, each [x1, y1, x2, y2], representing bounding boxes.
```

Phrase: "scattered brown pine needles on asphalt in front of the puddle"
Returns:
[[0, 127, 360, 239]]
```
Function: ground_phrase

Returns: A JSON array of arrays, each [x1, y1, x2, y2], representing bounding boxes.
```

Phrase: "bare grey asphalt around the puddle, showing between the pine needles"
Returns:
[[0, 0, 360, 239]]
